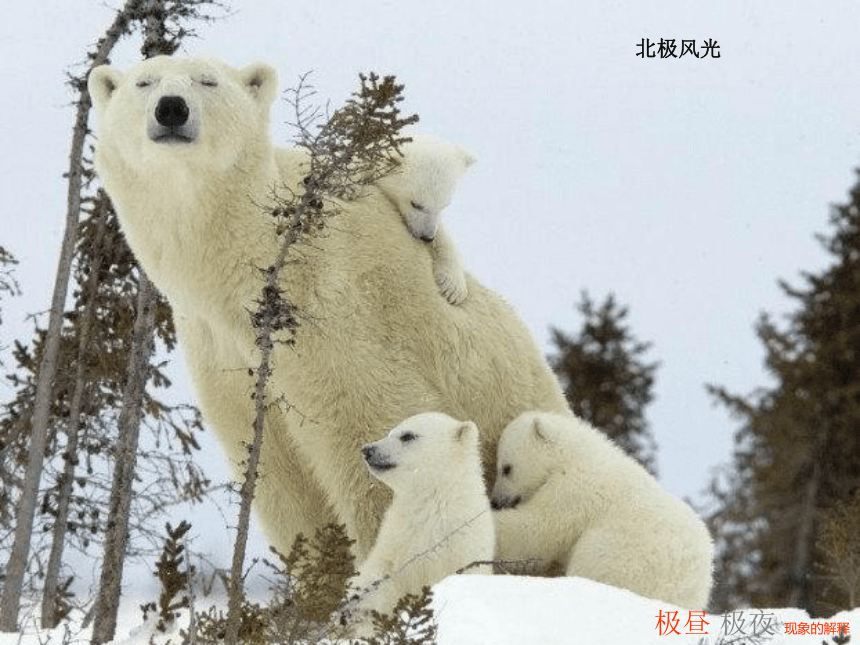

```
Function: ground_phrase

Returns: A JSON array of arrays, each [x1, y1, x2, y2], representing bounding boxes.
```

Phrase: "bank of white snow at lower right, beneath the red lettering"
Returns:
[[434, 576, 860, 645]]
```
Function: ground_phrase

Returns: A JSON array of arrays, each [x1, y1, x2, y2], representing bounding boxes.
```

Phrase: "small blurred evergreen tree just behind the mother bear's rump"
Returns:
[[549, 292, 658, 474]]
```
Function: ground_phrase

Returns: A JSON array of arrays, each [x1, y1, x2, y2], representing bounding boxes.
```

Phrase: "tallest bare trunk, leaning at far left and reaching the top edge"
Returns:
[[0, 5, 139, 632]]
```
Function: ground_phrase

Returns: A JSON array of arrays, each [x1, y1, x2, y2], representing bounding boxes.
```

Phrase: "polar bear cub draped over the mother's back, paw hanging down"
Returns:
[[377, 134, 475, 305]]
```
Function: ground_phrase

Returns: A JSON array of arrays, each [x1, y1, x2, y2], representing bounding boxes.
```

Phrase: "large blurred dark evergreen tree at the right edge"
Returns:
[[709, 166, 860, 615]]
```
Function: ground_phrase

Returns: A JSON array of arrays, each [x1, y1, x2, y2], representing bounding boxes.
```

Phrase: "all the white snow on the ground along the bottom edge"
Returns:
[[5, 575, 860, 645]]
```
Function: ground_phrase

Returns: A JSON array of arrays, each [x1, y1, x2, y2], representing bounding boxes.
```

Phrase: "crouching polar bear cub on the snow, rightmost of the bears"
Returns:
[[492, 412, 713, 609]]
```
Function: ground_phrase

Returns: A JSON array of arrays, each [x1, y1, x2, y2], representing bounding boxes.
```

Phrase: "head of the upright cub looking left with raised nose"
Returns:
[[361, 412, 480, 492]]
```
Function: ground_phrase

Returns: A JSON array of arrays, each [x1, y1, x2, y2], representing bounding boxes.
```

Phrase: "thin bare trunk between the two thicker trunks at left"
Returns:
[[41, 209, 107, 629]]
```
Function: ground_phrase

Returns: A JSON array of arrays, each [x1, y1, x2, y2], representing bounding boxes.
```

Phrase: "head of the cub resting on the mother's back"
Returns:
[[378, 134, 475, 242]]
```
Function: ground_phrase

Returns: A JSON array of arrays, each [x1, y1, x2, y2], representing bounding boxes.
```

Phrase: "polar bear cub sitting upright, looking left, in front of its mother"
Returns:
[[353, 412, 495, 612]]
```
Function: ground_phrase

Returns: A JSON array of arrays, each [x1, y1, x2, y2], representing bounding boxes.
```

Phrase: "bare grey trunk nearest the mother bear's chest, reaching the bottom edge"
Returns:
[[90, 271, 156, 645]]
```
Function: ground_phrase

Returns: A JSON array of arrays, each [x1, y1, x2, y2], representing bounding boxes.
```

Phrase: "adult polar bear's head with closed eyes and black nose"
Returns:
[[87, 56, 277, 180]]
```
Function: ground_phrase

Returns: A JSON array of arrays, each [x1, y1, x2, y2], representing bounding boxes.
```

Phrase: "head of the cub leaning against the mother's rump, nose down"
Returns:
[[491, 412, 563, 509]]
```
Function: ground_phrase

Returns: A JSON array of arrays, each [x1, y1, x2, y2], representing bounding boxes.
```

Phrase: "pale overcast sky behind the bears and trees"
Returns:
[[0, 0, 860, 568]]
